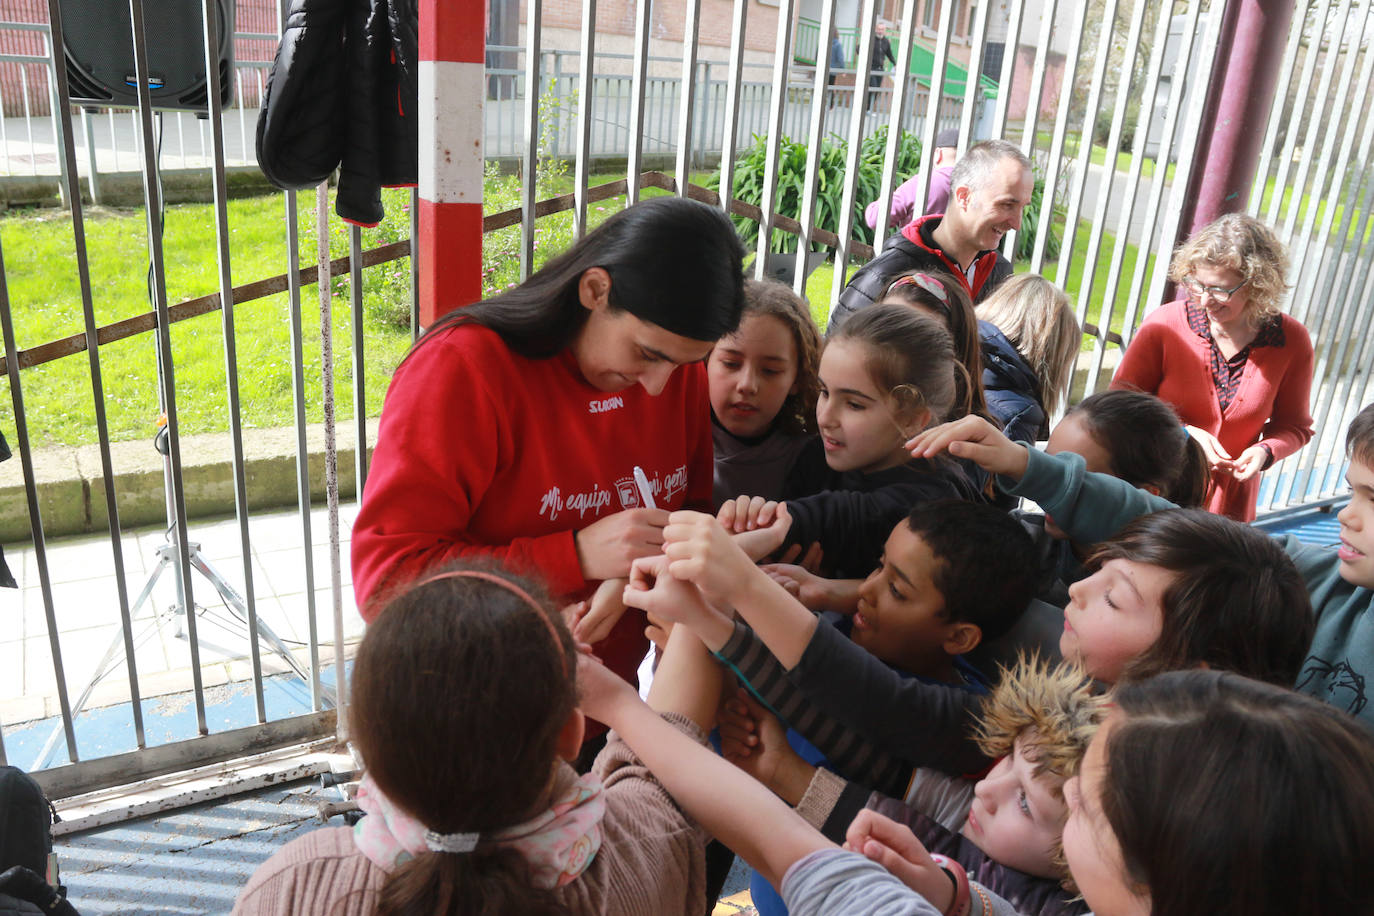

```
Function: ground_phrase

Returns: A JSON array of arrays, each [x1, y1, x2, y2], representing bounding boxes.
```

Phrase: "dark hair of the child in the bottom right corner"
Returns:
[[1104, 670, 1374, 916]]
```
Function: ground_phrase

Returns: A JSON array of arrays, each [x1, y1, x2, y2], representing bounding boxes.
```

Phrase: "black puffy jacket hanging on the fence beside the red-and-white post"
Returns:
[[257, 0, 419, 225]]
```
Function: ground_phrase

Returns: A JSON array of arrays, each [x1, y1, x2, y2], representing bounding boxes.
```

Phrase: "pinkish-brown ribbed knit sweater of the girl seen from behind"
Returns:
[[234, 714, 706, 916]]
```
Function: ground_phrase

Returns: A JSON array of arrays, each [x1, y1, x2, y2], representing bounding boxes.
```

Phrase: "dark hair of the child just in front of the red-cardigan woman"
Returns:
[[1065, 390, 1212, 508]]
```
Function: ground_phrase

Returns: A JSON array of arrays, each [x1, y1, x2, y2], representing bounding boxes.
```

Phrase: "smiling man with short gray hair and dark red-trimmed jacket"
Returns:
[[830, 140, 1032, 328]]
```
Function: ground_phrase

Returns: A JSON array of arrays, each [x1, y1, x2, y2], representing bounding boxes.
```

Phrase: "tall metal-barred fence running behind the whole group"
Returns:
[[0, 0, 1374, 794]]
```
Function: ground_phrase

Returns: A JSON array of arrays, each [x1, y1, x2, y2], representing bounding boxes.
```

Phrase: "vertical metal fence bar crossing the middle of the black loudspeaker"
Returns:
[[129, 0, 209, 735]]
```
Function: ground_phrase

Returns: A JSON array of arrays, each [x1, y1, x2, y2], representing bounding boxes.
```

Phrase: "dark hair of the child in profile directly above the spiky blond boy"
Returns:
[[1087, 509, 1315, 687]]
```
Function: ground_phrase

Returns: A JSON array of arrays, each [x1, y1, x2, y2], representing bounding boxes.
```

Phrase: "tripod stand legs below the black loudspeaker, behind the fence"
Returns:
[[29, 427, 335, 770]]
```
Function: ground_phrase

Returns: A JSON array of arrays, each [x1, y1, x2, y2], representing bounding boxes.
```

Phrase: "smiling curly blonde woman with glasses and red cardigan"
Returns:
[[1112, 213, 1312, 522]]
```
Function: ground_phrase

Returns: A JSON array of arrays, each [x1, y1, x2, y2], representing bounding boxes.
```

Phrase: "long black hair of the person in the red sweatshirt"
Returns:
[[415, 198, 745, 360]]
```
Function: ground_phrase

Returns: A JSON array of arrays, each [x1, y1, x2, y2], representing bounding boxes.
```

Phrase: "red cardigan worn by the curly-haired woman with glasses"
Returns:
[[1112, 299, 1312, 522]]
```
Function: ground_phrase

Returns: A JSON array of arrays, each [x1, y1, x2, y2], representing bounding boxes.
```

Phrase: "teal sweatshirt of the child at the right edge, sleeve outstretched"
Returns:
[[998, 449, 1374, 725]]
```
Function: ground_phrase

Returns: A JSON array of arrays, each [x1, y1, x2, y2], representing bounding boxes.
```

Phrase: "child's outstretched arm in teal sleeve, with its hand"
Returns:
[[907, 416, 1182, 544]]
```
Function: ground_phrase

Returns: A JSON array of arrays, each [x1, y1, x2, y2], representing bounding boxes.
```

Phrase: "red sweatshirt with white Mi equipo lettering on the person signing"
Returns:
[[353, 324, 712, 683]]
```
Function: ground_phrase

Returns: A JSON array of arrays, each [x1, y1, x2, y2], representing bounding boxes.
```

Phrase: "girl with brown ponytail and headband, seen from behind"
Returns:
[[234, 567, 719, 916]]
